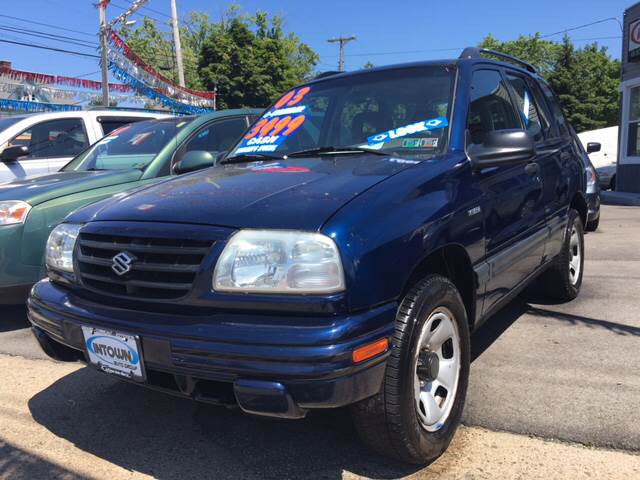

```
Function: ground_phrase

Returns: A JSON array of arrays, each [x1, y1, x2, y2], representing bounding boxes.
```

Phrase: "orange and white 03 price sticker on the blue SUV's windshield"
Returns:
[[234, 87, 311, 154]]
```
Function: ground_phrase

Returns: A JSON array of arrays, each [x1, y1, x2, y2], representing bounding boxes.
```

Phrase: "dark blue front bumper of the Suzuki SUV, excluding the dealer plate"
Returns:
[[28, 280, 397, 418]]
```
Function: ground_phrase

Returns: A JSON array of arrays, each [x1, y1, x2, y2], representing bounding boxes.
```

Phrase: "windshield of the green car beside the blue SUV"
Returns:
[[62, 117, 195, 171]]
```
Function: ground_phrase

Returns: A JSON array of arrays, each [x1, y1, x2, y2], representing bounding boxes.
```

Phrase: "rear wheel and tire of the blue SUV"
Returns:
[[540, 209, 584, 302]]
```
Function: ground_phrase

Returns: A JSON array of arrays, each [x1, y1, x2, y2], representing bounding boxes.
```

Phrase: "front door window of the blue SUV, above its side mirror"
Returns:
[[467, 70, 521, 144]]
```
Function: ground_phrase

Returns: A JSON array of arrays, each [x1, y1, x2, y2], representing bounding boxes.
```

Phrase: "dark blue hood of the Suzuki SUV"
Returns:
[[74, 154, 419, 230]]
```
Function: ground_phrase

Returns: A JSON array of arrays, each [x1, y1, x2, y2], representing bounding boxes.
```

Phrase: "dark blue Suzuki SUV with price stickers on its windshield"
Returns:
[[28, 48, 589, 464]]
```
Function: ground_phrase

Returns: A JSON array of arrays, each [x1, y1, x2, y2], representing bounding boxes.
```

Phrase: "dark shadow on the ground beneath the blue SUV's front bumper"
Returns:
[[28, 368, 419, 480]]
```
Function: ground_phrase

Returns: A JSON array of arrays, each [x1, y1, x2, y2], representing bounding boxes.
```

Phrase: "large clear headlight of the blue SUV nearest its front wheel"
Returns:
[[213, 230, 344, 293]]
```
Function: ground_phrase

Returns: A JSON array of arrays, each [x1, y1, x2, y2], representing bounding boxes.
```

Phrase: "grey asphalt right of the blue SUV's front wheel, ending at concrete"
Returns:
[[464, 206, 640, 451]]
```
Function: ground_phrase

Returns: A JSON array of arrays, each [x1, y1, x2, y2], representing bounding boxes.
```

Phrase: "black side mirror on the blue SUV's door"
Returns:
[[467, 130, 536, 170]]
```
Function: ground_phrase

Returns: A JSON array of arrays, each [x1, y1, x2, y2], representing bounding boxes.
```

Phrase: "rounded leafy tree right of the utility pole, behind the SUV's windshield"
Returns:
[[199, 6, 319, 108]]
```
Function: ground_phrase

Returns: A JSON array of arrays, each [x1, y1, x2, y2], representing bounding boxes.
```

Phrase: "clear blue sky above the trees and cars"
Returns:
[[0, 0, 633, 80]]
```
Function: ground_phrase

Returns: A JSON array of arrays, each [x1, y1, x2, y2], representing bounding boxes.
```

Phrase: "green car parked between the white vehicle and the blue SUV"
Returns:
[[0, 109, 261, 305]]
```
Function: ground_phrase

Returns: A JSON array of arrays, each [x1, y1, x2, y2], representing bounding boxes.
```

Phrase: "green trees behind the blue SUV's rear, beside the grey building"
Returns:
[[479, 34, 620, 132]]
